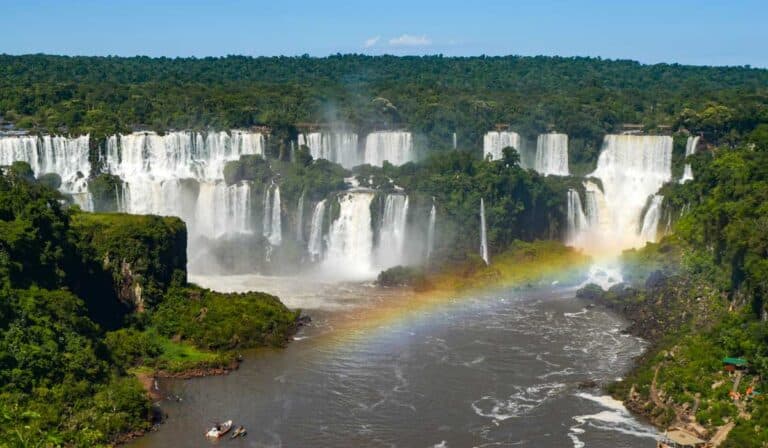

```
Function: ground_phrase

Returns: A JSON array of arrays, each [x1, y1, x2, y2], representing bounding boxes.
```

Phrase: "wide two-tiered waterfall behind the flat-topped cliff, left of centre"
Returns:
[[103, 130, 264, 271]]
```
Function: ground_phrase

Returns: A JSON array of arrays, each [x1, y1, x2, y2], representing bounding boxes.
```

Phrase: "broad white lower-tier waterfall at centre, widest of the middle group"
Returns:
[[323, 191, 375, 279]]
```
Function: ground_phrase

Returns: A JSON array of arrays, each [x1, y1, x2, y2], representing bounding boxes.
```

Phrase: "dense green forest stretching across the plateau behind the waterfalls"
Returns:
[[0, 55, 768, 163]]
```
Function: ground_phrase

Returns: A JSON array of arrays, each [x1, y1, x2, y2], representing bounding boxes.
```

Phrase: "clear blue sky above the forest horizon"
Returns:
[[0, 0, 768, 67]]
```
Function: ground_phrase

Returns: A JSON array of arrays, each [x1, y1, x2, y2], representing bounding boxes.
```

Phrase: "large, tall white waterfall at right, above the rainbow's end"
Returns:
[[568, 135, 672, 254]]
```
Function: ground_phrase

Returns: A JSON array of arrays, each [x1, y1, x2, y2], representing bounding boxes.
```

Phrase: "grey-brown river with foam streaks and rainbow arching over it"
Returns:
[[132, 276, 657, 448]]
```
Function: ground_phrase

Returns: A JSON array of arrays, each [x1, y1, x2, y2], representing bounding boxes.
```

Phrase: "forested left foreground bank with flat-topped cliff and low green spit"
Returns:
[[0, 163, 297, 447]]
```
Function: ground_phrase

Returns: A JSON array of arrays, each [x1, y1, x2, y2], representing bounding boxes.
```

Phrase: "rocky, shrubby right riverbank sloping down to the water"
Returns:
[[577, 242, 768, 447]]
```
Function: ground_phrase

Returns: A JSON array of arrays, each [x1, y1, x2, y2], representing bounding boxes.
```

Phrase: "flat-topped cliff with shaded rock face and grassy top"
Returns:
[[71, 213, 187, 320]]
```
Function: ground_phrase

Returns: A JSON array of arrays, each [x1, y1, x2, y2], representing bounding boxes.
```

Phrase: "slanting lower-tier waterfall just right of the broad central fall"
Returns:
[[377, 194, 408, 269]]
